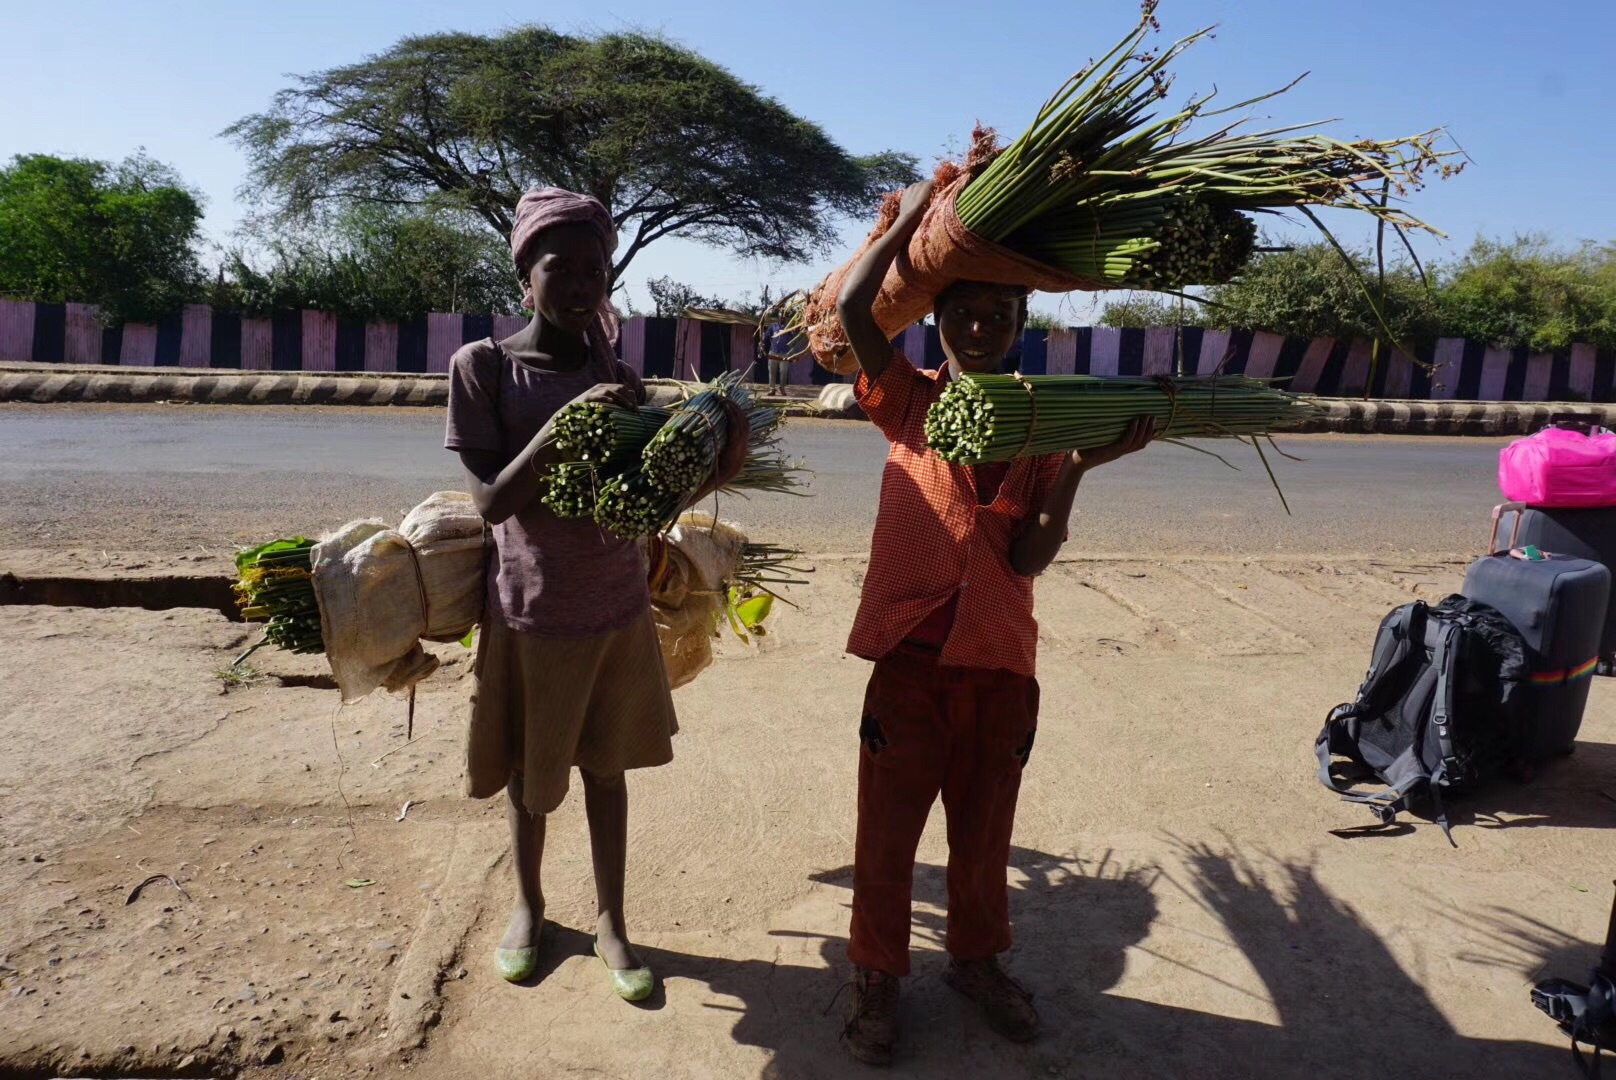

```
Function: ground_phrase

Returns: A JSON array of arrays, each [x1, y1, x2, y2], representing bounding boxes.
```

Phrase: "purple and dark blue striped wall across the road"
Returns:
[[0, 301, 1616, 403]]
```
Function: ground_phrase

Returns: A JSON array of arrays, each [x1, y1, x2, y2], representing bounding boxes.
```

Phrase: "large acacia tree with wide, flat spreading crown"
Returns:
[[225, 26, 916, 280]]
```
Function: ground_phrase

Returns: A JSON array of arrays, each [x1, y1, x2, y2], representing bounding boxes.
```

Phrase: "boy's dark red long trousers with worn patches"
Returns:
[[847, 645, 1037, 975]]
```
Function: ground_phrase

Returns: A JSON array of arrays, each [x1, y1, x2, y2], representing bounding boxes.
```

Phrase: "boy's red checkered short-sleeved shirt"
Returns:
[[847, 351, 1065, 676]]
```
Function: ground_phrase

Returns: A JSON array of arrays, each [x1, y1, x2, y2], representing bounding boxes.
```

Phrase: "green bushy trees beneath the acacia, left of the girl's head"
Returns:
[[213, 205, 520, 320]]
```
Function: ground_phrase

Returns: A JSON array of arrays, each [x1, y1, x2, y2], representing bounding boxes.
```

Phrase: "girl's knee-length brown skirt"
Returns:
[[465, 608, 679, 813]]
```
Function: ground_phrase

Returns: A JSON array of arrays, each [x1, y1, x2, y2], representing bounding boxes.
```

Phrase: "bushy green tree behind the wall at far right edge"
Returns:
[[1440, 236, 1616, 352]]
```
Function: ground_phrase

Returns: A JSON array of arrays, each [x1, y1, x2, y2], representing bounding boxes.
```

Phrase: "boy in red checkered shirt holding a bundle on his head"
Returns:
[[837, 183, 1154, 1064]]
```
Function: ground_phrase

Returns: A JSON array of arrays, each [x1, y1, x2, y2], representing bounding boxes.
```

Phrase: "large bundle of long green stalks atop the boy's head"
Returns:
[[955, 0, 1462, 289]]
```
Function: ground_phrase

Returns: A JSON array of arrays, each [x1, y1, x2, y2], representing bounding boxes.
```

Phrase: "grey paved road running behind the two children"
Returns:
[[0, 404, 1501, 555]]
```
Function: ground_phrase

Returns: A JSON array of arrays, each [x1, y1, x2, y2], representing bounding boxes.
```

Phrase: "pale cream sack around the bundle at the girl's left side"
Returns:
[[314, 491, 486, 702]]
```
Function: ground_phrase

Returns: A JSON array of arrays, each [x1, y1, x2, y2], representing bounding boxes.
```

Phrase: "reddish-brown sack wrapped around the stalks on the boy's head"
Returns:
[[805, 165, 1096, 375]]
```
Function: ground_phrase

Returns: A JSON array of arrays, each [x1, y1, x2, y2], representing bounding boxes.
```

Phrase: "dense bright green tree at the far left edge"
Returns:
[[0, 154, 202, 323]]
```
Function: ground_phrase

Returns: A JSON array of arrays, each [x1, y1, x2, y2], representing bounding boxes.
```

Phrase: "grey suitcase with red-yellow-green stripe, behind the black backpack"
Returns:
[[1464, 517, 1611, 758]]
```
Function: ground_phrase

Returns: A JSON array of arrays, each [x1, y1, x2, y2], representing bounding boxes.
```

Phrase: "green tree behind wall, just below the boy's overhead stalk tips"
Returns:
[[1204, 243, 1441, 344]]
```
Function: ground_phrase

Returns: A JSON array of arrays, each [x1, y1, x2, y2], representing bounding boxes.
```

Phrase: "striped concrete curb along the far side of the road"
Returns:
[[0, 364, 1616, 437]]
